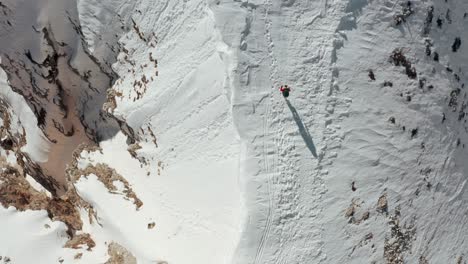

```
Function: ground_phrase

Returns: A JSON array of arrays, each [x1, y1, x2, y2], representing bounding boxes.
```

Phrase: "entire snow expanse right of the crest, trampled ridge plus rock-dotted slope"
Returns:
[[213, 1, 468, 263]]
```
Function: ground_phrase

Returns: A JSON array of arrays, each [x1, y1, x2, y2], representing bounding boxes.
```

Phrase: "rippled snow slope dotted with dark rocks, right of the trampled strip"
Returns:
[[325, 1, 468, 263]]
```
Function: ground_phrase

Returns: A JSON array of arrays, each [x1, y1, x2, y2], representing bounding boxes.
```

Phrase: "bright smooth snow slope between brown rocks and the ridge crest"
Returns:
[[90, 1, 245, 263]]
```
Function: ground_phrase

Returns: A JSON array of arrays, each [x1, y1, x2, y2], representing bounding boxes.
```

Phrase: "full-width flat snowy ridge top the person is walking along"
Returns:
[[213, 1, 341, 263]]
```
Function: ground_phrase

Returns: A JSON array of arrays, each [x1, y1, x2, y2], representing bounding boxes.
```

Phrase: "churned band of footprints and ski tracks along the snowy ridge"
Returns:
[[220, 1, 352, 263]]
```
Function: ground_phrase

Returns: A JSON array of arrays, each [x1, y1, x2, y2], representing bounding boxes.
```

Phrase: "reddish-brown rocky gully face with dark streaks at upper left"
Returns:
[[0, 0, 131, 193]]
